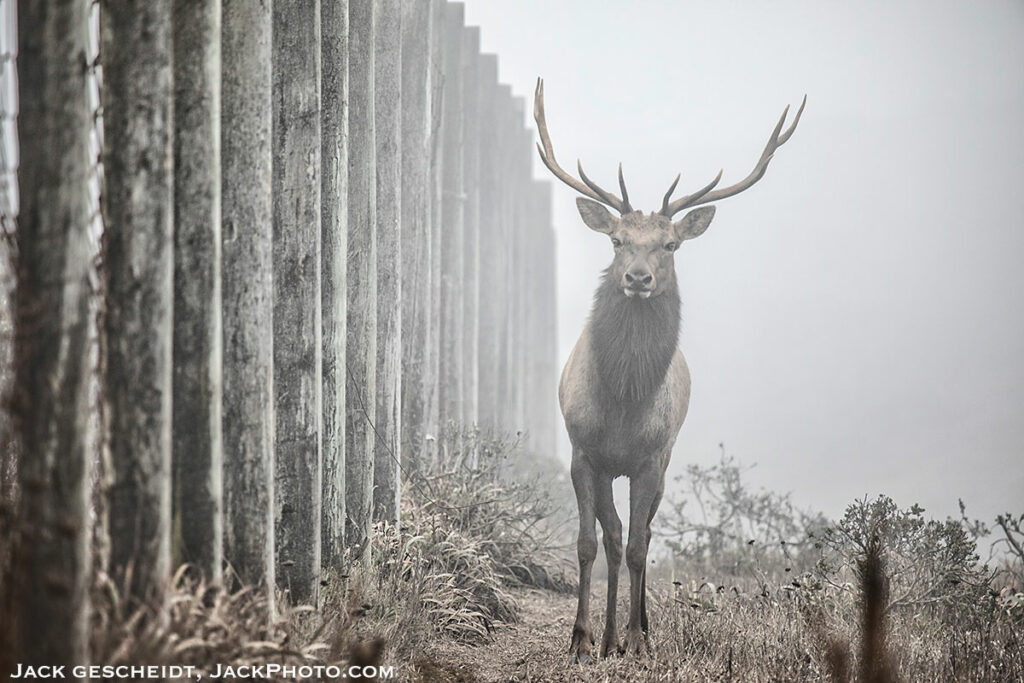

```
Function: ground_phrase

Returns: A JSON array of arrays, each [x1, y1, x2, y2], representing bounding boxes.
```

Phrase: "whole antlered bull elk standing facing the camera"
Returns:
[[534, 79, 807, 663]]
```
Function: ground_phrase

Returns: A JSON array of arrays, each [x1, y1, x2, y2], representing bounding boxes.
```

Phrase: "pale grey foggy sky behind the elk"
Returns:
[[466, 0, 1024, 518]]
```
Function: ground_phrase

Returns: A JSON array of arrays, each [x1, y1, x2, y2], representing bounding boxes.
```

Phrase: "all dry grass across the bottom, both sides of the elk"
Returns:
[[8, 421, 1024, 683]]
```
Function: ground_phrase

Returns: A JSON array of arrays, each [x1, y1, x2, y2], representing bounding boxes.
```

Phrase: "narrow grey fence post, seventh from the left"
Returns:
[[345, 0, 377, 562]]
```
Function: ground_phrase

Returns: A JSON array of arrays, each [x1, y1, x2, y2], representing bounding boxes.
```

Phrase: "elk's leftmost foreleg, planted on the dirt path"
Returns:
[[569, 452, 597, 664]]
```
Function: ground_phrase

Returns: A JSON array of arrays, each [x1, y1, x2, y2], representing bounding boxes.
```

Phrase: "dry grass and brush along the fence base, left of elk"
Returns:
[[0, 434, 570, 672]]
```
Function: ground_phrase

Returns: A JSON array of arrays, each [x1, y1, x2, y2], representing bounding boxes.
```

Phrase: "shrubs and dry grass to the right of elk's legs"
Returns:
[[655, 451, 1024, 681]]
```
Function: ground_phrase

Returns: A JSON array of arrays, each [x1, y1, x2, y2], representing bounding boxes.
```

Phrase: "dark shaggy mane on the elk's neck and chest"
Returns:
[[590, 270, 681, 402]]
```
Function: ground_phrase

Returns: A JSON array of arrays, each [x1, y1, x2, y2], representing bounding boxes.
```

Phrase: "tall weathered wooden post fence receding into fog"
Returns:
[[0, 0, 556, 665]]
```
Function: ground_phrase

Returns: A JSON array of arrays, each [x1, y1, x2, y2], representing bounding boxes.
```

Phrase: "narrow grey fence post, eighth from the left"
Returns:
[[373, 0, 402, 522]]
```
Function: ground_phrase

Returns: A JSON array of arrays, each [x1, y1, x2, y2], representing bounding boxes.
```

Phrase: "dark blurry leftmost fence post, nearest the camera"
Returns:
[[11, 0, 94, 673]]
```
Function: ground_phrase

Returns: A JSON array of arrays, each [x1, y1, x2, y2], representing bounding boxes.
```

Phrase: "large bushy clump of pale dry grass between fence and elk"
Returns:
[[329, 427, 572, 663]]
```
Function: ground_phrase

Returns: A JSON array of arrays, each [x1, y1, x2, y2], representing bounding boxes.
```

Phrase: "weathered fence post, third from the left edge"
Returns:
[[172, 0, 224, 583]]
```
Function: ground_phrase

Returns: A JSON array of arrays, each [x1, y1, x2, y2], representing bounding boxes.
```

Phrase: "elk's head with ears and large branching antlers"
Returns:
[[534, 79, 807, 299]]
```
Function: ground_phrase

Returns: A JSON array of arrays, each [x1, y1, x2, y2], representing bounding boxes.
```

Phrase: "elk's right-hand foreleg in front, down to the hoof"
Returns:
[[625, 467, 663, 654]]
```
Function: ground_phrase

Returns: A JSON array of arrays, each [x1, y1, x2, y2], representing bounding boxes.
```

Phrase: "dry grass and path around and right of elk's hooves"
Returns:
[[403, 489, 1024, 683]]
